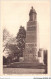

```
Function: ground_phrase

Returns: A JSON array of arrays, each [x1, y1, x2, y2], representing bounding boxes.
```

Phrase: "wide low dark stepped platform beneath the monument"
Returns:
[[7, 62, 45, 69]]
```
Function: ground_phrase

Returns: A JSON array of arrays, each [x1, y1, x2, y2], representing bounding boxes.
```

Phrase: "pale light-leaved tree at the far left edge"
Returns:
[[3, 29, 15, 64]]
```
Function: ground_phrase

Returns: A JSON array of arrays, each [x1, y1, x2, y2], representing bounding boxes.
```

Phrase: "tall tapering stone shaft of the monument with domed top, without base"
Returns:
[[23, 7, 37, 62]]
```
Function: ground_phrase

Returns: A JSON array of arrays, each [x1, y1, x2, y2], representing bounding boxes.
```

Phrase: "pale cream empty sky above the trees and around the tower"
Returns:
[[1, 0, 50, 49]]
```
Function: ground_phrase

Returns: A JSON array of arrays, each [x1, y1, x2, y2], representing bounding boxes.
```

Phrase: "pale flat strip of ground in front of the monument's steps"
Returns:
[[3, 68, 45, 74]]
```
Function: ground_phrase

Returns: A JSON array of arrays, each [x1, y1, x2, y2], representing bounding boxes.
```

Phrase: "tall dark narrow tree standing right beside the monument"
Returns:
[[16, 26, 26, 59]]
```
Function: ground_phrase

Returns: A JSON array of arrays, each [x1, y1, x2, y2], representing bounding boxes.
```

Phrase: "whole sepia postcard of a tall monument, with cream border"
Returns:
[[1, 0, 50, 75]]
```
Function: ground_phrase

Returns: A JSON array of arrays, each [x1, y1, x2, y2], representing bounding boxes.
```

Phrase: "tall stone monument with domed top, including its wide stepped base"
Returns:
[[16, 7, 44, 67]]
